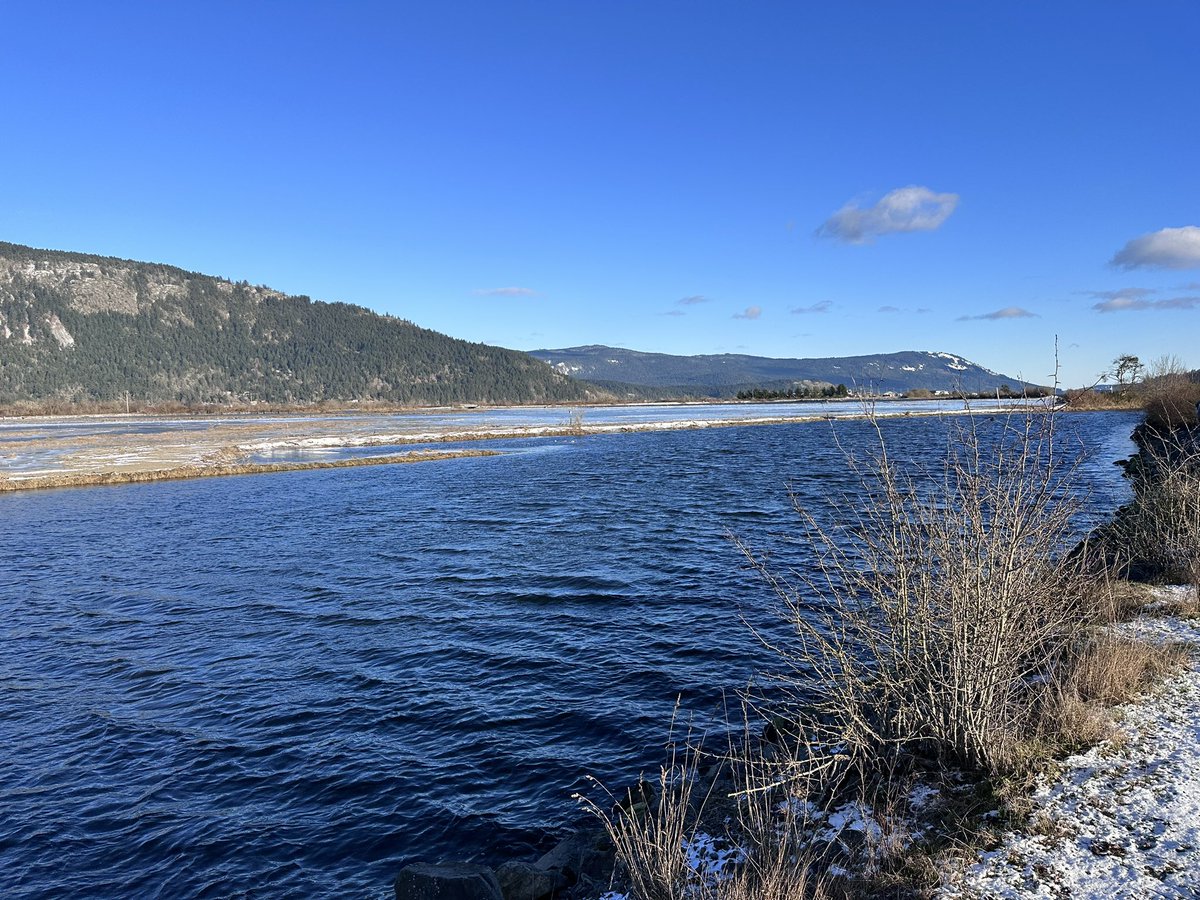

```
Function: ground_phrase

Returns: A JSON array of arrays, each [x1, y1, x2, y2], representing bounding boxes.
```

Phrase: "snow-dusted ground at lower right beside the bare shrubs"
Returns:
[[938, 587, 1200, 900]]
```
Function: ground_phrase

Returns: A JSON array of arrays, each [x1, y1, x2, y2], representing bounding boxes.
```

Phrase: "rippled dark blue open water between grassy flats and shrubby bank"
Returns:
[[0, 413, 1136, 898]]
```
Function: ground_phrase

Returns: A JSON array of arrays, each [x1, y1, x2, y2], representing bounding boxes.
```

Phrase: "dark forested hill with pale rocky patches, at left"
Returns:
[[0, 242, 590, 404]]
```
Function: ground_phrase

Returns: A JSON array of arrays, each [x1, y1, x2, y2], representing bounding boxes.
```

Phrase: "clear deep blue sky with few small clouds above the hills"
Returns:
[[0, 0, 1200, 384]]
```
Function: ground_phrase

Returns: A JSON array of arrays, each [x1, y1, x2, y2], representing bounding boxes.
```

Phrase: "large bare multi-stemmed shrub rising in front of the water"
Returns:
[[743, 414, 1094, 779]]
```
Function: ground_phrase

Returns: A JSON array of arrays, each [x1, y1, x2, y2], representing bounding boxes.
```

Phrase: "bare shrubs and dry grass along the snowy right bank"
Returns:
[[586, 391, 1200, 900]]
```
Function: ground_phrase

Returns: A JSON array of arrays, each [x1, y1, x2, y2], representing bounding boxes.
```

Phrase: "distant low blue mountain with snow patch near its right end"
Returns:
[[530, 344, 1032, 396]]
